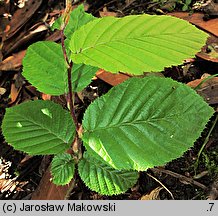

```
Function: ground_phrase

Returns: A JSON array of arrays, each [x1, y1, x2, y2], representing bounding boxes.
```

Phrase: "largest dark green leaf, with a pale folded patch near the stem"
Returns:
[[82, 76, 213, 170]]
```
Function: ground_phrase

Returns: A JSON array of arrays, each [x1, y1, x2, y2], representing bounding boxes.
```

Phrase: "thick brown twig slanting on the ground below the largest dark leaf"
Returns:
[[150, 168, 207, 190]]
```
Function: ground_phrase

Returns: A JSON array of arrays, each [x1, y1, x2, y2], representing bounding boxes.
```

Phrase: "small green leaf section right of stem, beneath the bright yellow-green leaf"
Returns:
[[72, 64, 98, 92]]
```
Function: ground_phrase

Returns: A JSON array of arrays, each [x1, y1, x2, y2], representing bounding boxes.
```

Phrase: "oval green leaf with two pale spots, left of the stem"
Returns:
[[2, 100, 75, 155]]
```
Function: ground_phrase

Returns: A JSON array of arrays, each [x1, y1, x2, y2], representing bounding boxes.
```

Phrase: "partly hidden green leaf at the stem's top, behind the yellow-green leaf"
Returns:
[[52, 4, 97, 38]]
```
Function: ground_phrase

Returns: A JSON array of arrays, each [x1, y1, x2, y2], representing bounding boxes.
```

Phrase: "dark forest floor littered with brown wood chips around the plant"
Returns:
[[0, 0, 218, 200]]
